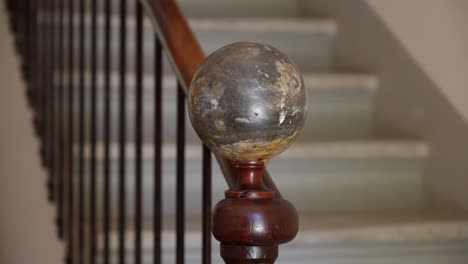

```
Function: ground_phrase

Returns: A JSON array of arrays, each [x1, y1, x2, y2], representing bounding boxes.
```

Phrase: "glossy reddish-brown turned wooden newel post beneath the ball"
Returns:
[[213, 158, 298, 264]]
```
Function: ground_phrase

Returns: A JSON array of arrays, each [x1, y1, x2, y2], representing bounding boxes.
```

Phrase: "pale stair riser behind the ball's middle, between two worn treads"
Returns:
[[57, 78, 374, 142]]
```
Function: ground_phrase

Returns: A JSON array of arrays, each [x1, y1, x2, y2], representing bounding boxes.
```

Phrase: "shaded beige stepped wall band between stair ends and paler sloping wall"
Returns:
[[302, 0, 468, 209]]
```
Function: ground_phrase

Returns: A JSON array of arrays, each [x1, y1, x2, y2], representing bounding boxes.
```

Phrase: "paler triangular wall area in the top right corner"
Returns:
[[366, 0, 468, 124]]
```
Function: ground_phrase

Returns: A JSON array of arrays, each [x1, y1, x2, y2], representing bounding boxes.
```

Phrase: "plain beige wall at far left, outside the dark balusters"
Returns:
[[0, 4, 64, 264]]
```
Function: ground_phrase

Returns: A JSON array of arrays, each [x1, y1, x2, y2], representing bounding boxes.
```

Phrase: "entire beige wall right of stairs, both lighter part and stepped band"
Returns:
[[302, 0, 468, 209]]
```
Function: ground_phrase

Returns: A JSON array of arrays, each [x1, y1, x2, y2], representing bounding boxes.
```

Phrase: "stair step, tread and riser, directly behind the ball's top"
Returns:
[[40, 15, 336, 72]]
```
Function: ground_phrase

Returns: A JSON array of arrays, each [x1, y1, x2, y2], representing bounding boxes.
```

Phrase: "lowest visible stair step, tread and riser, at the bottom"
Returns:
[[94, 209, 468, 264]]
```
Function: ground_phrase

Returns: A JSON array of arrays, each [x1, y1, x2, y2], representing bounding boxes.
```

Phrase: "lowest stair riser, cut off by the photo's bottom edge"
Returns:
[[94, 242, 468, 264]]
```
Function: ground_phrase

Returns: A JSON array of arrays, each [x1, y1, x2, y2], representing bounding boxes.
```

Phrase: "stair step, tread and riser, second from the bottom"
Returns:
[[80, 140, 429, 215]]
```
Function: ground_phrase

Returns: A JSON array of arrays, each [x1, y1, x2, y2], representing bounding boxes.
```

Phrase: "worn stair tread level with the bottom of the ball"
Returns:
[[89, 139, 429, 159]]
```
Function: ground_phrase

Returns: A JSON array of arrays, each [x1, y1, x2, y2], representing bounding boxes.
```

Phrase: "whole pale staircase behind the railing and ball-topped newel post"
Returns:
[[40, 0, 468, 264]]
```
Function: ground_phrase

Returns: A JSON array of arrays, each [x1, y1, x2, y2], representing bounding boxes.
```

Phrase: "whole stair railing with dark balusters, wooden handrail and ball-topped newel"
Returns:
[[6, 0, 305, 264]]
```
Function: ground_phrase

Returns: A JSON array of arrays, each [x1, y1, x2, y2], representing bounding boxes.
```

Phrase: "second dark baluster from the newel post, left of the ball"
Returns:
[[176, 83, 185, 264]]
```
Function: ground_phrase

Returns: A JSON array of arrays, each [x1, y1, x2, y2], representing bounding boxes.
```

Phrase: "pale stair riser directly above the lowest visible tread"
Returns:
[[78, 155, 423, 217]]
